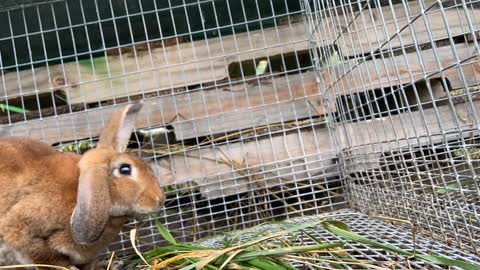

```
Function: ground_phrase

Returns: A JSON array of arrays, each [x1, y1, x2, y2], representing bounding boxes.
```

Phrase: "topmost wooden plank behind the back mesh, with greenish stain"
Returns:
[[0, 23, 308, 104]]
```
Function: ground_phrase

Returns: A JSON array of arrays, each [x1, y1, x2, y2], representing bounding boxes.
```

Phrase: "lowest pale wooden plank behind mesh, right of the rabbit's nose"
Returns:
[[157, 128, 339, 199]]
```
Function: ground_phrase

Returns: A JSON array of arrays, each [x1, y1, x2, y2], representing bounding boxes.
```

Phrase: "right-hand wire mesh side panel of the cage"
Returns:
[[306, 0, 480, 253]]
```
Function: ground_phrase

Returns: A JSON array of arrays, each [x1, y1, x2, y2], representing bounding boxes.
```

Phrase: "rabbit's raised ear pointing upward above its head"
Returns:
[[98, 101, 143, 152]]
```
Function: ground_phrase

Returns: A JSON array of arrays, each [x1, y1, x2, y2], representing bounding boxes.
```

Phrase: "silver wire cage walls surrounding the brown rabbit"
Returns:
[[0, 0, 480, 269]]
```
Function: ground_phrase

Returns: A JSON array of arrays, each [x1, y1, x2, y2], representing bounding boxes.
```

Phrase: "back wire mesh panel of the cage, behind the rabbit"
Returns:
[[0, 0, 346, 256]]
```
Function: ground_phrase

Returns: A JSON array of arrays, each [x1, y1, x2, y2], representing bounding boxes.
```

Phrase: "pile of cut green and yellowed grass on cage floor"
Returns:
[[126, 217, 480, 270]]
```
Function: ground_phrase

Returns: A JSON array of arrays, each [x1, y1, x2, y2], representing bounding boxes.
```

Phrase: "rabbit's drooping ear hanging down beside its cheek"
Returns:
[[70, 167, 111, 245]]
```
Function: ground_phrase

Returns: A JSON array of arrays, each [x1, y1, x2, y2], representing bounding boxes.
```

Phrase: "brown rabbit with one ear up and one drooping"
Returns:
[[0, 103, 164, 269]]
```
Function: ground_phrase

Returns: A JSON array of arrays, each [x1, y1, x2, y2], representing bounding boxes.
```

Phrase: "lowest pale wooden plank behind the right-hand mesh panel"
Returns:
[[335, 97, 480, 154]]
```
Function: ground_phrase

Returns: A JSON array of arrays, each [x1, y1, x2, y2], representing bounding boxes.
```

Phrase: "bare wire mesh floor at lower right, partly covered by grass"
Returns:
[[188, 209, 480, 269]]
